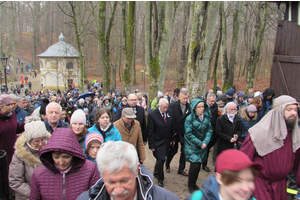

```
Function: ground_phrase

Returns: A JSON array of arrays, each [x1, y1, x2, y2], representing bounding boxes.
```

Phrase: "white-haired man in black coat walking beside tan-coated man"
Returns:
[[148, 98, 174, 187]]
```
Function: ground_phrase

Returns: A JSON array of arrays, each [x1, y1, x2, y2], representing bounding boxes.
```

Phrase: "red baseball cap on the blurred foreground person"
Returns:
[[216, 149, 263, 174]]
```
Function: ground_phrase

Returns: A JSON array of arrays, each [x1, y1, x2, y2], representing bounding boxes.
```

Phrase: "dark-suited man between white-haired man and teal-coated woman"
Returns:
[[166, 88, 191, 176]]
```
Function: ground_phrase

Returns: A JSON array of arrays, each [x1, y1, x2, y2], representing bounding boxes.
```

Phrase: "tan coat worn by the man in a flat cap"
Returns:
[[114, 117, 146, 160]]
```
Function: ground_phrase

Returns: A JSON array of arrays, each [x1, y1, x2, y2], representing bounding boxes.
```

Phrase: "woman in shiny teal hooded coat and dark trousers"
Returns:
[[184, 99, 212, 192]]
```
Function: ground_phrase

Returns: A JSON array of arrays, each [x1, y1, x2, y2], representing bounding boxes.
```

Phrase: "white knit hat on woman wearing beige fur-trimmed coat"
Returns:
[[23, 116, 50, 142]]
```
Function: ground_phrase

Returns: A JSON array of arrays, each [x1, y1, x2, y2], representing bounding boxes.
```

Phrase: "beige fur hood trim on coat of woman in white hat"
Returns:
[[15, 133, 51, 167]]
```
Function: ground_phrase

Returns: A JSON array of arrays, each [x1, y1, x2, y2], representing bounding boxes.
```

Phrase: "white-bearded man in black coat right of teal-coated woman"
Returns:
[[215, 102, 243, 156]]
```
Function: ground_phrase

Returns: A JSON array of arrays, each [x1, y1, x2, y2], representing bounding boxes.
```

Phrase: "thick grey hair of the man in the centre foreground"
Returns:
[[96, 141, 139, 174]]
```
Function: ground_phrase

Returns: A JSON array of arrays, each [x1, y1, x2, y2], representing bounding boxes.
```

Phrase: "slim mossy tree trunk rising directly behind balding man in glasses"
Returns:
[[123, 1, 135, 93]]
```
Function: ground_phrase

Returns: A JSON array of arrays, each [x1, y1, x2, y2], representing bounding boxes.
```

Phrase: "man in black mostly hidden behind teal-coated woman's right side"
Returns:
[[202, 93, 218, 172]]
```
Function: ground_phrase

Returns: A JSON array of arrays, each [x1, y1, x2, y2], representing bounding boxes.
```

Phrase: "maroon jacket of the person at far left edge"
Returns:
[[0, 112, 24, 166]]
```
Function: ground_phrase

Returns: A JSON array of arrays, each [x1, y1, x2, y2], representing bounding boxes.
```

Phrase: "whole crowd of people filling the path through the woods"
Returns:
[[0, 81, 300, 200]]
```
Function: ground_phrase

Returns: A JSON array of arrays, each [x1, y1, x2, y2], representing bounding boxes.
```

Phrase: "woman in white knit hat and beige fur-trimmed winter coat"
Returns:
[[9, 117, 51, 200]]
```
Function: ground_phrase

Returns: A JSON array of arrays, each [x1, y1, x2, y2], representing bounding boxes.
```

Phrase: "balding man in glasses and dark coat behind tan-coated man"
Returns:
[[114, 94, 148, 142]]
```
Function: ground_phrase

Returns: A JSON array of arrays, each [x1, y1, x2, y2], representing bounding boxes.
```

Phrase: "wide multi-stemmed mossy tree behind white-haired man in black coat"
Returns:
[[145, 2, 178, 102]]
